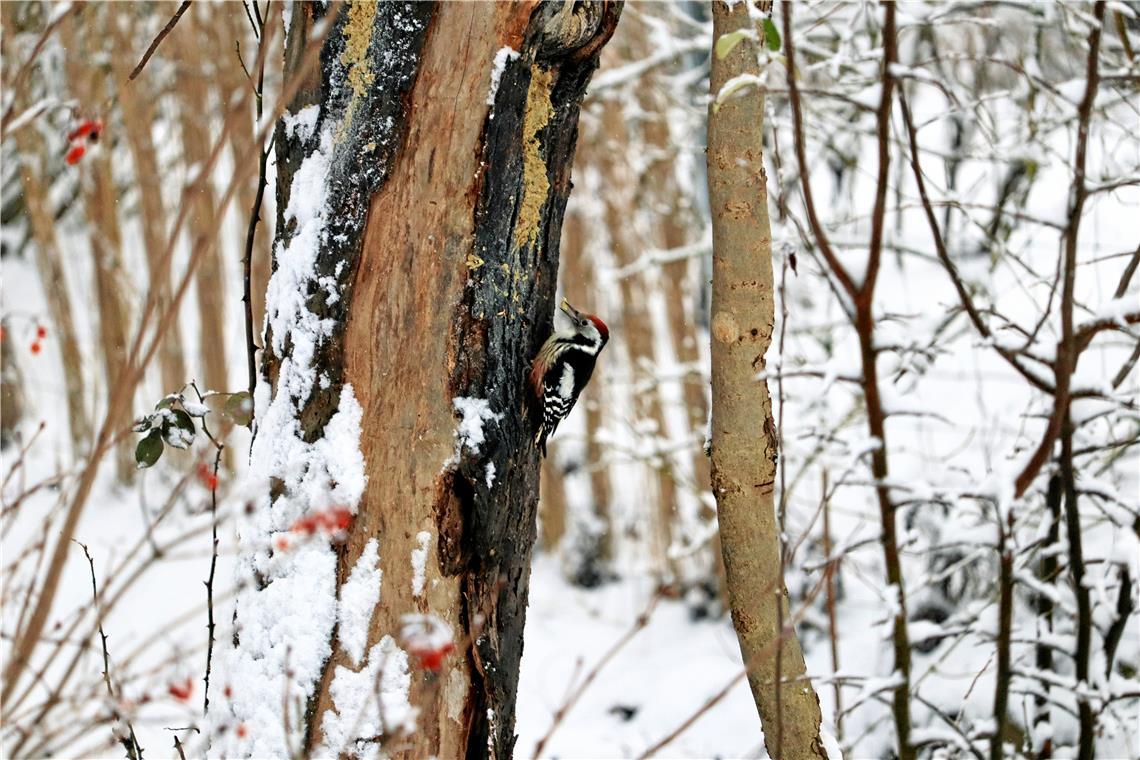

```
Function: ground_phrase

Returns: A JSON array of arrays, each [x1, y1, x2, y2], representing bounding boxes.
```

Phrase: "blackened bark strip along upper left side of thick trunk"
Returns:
[[262, 2, 434, 442]]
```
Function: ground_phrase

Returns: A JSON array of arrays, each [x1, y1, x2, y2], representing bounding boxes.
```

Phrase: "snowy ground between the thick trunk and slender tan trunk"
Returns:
[[516, 556, 766, 758]]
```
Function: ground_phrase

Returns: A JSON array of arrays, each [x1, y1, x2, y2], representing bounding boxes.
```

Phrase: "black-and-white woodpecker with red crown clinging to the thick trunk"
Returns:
[[530, 299, 610, 457]]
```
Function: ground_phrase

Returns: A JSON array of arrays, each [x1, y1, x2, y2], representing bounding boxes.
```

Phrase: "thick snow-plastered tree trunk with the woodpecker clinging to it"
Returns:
[[212, 2, 620, 758]]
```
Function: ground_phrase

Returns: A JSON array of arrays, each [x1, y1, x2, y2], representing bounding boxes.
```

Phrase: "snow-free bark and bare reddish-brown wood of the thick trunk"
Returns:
[[255, 2, 620, 758]]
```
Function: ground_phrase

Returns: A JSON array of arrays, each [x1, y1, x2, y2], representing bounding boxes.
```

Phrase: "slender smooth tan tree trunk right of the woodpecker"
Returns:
[[708, 2, 827, 760]]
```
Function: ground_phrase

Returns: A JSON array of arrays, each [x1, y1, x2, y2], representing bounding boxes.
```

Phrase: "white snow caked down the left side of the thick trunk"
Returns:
[[207, 123, 364, 757]]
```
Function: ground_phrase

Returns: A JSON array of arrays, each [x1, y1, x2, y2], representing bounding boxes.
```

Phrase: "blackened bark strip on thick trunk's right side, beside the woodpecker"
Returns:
[[453, 2, 620, 758]]
